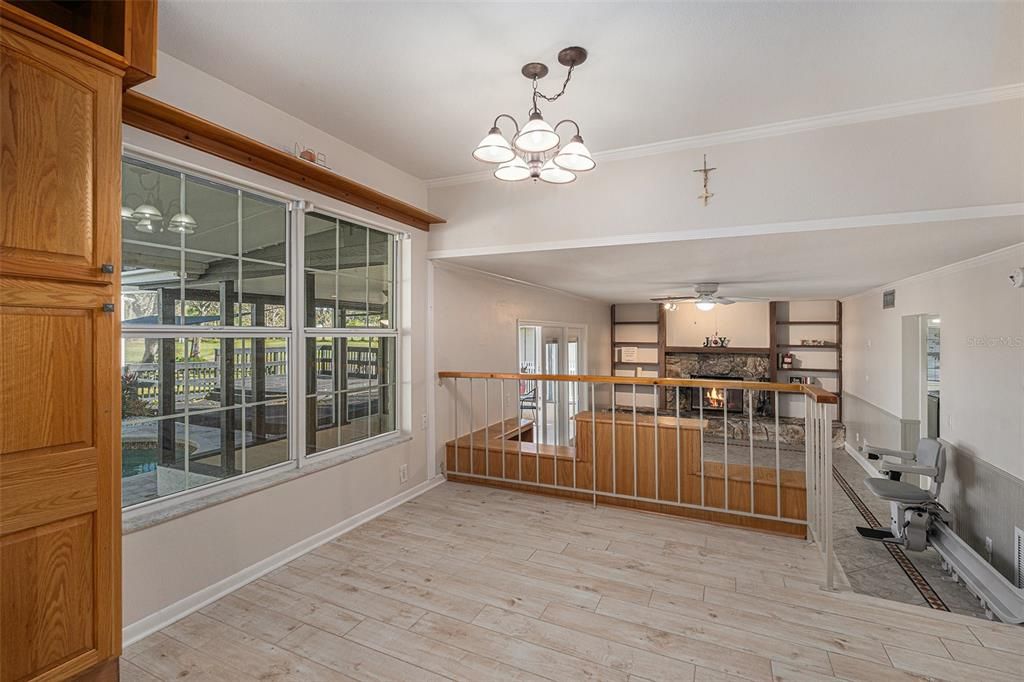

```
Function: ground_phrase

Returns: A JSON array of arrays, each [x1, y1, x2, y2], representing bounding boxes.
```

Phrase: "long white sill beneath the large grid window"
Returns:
[[121, 431, 413, 536]]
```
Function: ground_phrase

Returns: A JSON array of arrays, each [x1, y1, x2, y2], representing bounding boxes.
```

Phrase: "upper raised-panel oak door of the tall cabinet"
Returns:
[[0, 26, 121, 282]]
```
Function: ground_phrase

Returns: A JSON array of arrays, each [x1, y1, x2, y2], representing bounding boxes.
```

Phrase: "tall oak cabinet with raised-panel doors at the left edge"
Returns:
[[0, 18, 124, 682]]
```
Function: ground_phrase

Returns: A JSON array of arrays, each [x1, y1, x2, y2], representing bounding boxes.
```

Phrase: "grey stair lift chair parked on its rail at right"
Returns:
[[857, 438, 948, 552]]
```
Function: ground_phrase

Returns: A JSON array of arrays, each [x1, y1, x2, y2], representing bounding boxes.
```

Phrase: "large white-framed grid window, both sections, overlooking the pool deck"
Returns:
[[121, 158, 397, 507]]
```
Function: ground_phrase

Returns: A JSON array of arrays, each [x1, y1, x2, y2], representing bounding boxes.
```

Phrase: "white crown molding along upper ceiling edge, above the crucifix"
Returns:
[[424, 83, 1024, 189]]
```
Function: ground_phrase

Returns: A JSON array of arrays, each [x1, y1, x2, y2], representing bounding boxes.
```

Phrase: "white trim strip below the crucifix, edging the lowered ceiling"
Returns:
[[427, 203, 1024, 260]]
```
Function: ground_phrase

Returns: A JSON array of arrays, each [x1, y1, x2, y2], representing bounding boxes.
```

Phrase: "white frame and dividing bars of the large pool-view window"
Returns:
[[118, 144, 410, 509]]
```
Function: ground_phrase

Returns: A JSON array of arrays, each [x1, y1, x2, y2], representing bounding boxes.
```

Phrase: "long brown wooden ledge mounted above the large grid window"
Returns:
[[122, 90, 444, 230]]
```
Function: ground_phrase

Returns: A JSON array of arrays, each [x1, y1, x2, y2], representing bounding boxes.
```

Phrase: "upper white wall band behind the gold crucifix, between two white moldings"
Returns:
[[429, 99, 1024, 253]]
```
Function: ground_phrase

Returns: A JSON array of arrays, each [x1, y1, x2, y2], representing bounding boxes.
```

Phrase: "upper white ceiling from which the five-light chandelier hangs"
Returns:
[[160, 0, 1024, 178]]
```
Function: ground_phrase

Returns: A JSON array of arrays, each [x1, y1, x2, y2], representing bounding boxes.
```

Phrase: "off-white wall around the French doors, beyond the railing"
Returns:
[[433, 264, 611, 473]]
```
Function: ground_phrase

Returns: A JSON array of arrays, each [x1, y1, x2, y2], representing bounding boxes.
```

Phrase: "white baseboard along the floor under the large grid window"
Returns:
[[121, 476, 444, 646]]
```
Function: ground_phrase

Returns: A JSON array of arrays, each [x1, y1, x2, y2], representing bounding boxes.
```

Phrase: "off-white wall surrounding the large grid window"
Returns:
[[123, 54, 430, 627]]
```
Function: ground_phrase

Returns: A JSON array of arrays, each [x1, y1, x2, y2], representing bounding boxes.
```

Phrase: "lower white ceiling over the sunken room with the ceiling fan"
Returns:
[[444, 216, 1024, 303]]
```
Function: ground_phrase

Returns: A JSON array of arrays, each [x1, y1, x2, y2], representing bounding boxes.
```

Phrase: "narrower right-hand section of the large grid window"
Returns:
[[303, 212, 397, 455]]
